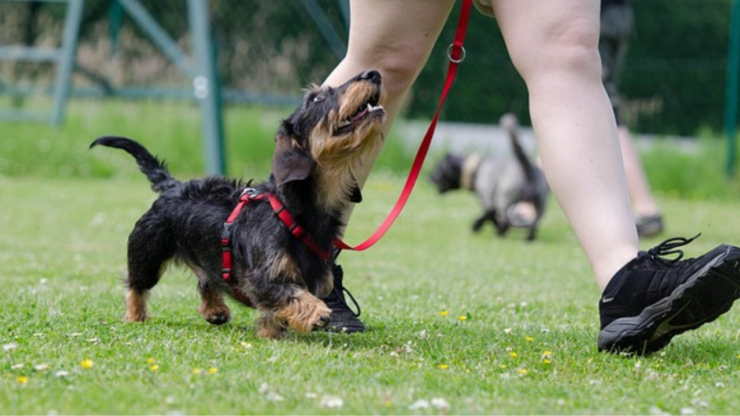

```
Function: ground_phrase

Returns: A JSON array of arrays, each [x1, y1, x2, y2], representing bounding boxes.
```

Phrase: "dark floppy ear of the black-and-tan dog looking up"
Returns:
[[272, 130, 316, 186]]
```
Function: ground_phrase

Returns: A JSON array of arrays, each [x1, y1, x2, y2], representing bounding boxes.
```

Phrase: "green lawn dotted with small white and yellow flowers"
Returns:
[[0, 171, 740, 414]]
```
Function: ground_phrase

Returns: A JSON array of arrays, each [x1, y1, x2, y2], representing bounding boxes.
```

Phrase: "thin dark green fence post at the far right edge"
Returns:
[[725, 0, 740, 177]]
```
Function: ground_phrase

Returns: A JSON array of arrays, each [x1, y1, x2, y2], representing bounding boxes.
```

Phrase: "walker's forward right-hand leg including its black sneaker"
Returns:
[[494, 0, 740, 353]]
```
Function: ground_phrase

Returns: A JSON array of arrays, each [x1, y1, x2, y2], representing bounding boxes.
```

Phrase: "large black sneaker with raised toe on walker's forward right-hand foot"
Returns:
[[598, 236, 740, 354]]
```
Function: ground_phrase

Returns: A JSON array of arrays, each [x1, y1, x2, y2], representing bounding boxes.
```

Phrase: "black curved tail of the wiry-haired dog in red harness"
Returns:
[[90, 136, 180, 193]]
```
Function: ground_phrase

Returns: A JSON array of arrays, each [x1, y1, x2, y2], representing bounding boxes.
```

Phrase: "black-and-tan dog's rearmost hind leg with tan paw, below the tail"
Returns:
[[124, 211, 175, 322]]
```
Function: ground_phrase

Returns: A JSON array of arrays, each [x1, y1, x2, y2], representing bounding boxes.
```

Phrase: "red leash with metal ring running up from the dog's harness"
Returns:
[[334, 0, 472, 251]]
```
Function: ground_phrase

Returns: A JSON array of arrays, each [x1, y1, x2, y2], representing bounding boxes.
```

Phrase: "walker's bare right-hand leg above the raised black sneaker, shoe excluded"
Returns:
[[493, 0, 638, 289]]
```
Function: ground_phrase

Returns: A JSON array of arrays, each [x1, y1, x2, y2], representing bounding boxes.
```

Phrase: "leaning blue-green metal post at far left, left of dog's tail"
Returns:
[[51, 0, 84, 125]]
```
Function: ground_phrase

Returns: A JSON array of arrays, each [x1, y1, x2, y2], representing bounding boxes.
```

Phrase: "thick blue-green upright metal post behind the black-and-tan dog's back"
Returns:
[[188, 0, 226, 175]]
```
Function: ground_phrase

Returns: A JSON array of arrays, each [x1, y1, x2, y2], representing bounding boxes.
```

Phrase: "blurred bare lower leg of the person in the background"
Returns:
[[619, 126, 659, 217]]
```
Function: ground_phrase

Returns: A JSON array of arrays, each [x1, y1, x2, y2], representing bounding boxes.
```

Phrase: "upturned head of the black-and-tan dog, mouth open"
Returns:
[[272, 70, 385, 210]]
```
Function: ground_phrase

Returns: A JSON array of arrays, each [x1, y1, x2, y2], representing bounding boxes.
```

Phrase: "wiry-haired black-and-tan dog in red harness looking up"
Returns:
[[90, 71, 385, 338]]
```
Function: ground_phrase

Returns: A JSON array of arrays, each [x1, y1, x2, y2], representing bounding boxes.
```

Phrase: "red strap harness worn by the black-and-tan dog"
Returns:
[[221, 188, 331, 281]]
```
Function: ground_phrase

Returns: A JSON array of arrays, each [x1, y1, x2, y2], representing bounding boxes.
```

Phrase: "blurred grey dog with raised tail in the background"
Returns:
[[431, 114, 550, 241]]
